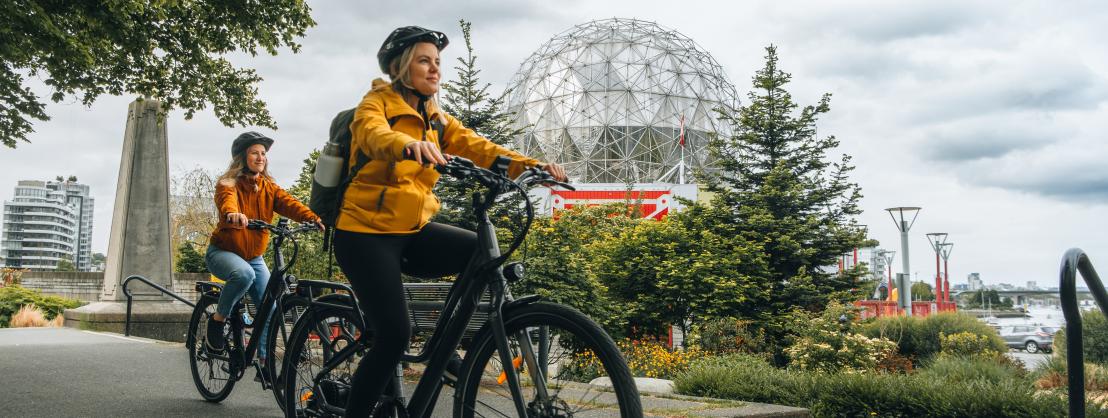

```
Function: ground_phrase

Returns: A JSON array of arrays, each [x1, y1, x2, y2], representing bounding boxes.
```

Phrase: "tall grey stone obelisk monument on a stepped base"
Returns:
[[65, 99, 191, 341]]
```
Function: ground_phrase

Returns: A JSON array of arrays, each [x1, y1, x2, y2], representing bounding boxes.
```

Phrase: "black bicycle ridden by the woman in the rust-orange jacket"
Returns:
[[185, 217, 334, 407]]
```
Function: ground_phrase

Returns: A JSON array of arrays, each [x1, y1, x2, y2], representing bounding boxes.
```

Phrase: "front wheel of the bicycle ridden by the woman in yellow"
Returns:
[[454, 303, 643, 418]]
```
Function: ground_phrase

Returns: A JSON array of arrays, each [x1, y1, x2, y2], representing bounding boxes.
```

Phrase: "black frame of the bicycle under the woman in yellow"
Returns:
[[301, 161, 558, 418]]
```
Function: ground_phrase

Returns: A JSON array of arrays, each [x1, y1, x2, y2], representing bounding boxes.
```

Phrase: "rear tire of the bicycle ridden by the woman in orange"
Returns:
[[185, 295, 237, 402]]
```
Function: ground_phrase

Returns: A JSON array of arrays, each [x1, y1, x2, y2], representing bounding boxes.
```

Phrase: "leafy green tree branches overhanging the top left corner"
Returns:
[[0, 0, 315, 147]]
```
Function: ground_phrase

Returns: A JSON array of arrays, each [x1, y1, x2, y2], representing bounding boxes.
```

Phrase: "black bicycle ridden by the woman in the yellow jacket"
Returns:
[[284, 156, 643, 418]]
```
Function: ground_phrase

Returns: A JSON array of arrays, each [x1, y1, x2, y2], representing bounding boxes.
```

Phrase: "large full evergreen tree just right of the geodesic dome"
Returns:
[[704, 45, 864, 328]]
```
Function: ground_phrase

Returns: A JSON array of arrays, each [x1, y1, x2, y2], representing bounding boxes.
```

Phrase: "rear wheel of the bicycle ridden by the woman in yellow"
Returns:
[[281, 299, 365, 417]]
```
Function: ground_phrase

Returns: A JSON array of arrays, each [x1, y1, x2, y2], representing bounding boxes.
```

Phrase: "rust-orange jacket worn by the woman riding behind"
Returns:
[[211, 175, 319, 261]]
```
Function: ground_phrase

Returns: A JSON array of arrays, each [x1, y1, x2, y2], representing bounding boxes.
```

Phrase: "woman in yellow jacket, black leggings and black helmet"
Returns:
[[335, 27, 565, 417]]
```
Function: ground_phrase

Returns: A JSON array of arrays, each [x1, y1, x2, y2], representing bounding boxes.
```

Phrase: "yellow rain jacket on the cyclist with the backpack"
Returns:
[[338, 79, 538, 234]]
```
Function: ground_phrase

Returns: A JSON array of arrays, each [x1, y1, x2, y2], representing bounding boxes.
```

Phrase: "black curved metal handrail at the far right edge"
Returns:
[[1058, 248, 1108, 418]]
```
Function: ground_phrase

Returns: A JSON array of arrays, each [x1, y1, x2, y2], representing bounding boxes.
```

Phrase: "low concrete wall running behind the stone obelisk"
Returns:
[[20, 272, 208, 303]]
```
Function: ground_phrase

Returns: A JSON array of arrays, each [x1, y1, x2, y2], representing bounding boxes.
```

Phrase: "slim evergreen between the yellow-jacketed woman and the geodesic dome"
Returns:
[[434, 20, 523, 231]]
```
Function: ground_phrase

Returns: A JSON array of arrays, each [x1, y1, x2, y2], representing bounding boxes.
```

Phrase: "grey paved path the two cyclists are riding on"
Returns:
[[0, 328, 806, 418]]
